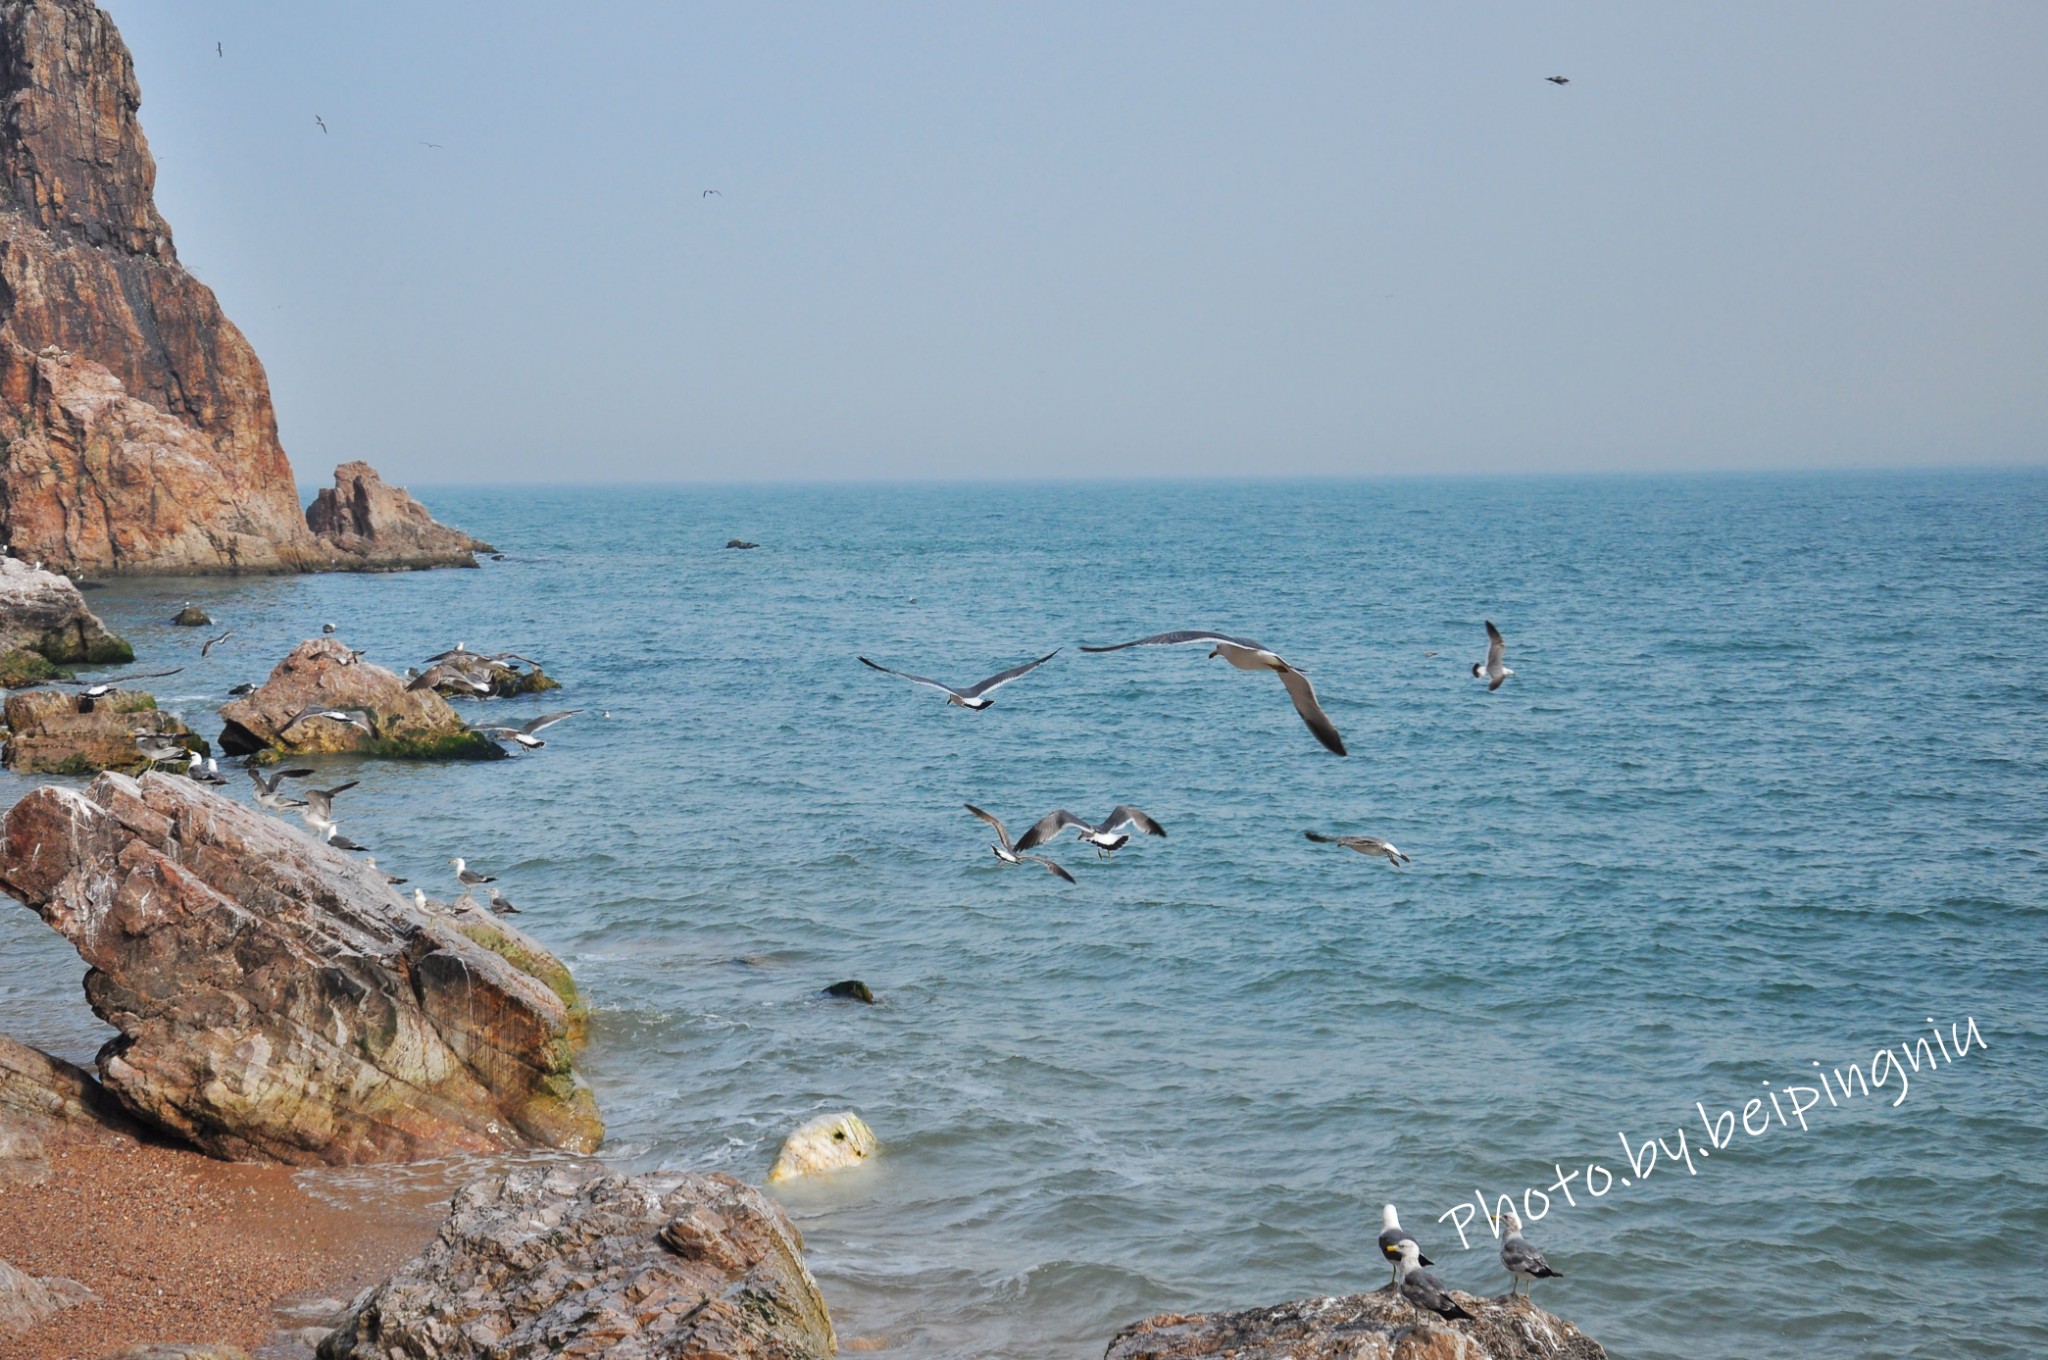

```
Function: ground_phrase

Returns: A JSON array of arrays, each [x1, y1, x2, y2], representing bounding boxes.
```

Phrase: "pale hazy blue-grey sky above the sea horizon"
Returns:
[[106, 0, 2048, 481]]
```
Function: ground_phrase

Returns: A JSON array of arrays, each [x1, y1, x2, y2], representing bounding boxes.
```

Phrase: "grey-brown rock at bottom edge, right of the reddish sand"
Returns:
[[319, 1167, 838, 1360]]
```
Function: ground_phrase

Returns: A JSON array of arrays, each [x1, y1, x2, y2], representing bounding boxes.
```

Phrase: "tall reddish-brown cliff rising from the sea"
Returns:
[[0, 0, 473, 571]]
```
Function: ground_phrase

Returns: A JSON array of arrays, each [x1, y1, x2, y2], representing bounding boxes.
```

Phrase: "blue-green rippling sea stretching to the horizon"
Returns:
[[0, 471, 2048, 1360]]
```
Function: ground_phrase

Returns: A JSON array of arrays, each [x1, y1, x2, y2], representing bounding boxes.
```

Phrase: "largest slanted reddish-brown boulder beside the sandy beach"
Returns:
[[0, 774, 604, 1165]]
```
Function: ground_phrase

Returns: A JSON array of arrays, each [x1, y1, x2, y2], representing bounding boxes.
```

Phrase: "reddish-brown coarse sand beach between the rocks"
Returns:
[[0, 1137, 444, 1360]]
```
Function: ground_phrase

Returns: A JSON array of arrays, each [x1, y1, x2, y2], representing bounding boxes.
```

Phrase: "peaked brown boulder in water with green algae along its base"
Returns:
[[221, 637, 504, 760]]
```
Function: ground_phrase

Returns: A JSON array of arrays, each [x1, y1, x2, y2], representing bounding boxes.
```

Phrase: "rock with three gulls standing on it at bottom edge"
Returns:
[[1104, 1286, 1608, 1360]]
